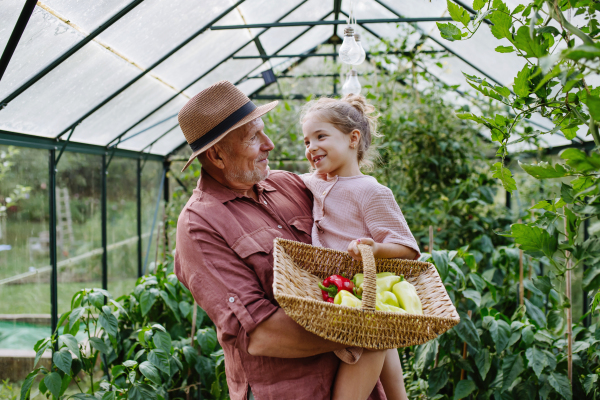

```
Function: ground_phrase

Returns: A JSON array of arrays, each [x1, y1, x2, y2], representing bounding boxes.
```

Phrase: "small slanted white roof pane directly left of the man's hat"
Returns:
[[119, 96, 189, 152]]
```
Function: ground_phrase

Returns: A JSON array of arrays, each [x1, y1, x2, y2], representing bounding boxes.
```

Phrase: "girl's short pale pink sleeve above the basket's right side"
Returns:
[[363, 186, 421, 259]]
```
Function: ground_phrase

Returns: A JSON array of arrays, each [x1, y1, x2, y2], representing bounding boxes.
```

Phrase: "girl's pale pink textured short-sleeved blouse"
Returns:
[[300, 173, 421, 258]]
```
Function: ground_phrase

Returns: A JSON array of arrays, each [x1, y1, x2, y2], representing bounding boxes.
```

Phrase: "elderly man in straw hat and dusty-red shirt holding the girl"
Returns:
[[175, 81, 385, 400]]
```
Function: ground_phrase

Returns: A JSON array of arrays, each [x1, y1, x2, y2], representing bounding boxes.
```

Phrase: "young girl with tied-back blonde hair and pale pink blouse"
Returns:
[[301, 94, 420, 400]]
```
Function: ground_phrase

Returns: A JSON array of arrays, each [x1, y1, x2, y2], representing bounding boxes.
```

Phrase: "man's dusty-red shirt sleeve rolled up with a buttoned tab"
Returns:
[[175, 209, 278, 353]]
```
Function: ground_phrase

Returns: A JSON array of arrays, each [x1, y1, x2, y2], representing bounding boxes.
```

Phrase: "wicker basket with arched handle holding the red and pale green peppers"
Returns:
[[273, 238, 460, 349]]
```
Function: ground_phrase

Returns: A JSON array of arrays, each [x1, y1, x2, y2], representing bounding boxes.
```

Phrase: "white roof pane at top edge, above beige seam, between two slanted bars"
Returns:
[[99, 0, 242, 68]]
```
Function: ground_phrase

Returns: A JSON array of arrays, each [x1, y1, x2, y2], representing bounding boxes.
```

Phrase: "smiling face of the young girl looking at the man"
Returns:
[[302, 112, 361, 177]]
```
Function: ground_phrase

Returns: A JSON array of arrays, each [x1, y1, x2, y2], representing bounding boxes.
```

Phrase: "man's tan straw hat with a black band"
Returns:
[[178, 81, 278, 172]]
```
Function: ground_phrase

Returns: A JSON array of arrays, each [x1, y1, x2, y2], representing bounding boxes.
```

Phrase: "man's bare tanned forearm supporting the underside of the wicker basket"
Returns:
[[248, 308, 348, 358]]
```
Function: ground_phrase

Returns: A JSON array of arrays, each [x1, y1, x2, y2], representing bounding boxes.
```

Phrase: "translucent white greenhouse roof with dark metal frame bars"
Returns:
[[0, 0, 587, 157]]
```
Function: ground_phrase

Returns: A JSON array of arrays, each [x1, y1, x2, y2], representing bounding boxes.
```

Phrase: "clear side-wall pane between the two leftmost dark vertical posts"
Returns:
[[56, 152, 102, 314]]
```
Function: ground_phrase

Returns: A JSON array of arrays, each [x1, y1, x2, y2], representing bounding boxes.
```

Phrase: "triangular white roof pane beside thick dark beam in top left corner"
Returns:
[[0, 2, 84, 99]]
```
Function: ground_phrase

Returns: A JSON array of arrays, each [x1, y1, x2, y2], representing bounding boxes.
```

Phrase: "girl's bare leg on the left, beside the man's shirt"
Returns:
[[332, 349, 387, 400]]
